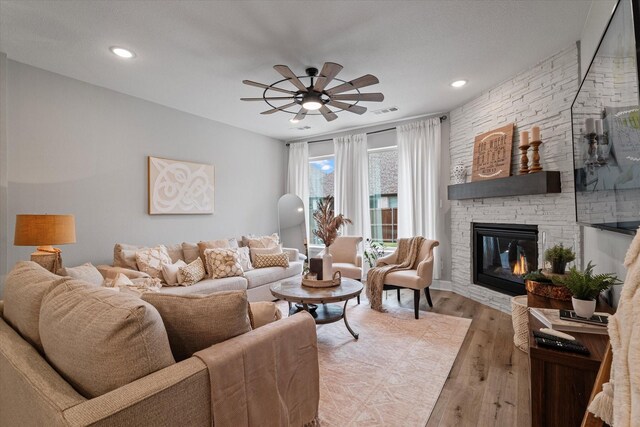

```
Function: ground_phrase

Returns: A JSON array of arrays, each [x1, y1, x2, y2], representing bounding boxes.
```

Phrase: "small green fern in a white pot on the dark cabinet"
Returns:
[[553, 261, 620, 319]]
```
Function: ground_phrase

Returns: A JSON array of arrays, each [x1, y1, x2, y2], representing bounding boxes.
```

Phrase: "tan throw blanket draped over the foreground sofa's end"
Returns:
[[194, 314, 320, 427]]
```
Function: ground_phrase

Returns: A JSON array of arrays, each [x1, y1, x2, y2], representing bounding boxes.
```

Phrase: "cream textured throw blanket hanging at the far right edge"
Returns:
[[609, 229, 640, 427]]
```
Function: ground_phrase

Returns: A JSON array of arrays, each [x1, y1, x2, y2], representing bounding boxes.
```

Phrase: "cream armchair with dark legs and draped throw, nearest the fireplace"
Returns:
[[376, 239, 440, 319]]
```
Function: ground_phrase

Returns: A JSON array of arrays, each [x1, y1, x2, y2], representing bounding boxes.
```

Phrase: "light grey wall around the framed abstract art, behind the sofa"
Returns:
[[0, 60, 285, 290]]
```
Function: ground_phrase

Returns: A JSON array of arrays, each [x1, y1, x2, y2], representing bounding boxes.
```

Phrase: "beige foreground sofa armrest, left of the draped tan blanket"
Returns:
[[63, 357, 212, 426]]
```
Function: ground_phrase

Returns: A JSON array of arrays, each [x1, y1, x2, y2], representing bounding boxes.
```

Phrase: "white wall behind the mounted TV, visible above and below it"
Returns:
[[580, 0, 632, 303]]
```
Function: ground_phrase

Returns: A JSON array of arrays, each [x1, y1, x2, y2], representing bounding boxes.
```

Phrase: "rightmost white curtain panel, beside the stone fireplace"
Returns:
[[396, 117, 440, 279]]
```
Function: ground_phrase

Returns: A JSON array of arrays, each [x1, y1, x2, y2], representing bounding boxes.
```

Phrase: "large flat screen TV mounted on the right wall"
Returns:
[[571, 0, 640, 234]]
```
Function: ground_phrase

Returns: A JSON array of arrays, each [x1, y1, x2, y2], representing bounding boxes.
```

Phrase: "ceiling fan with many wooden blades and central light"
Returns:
[[240, 62, 384, 123]]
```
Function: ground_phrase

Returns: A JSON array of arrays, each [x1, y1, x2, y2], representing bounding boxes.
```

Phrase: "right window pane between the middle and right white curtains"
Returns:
[[369, 148, 398, 243]]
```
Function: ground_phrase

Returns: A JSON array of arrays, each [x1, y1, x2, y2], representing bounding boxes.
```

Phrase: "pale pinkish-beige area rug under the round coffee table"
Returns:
[[280, 300, 471, 427]]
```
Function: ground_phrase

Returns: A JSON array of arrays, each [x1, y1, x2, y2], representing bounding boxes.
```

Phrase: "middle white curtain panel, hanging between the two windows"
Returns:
[[333, 133, 371, 239]]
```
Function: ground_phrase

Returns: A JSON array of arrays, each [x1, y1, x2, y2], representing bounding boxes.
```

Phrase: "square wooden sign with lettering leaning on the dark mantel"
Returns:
[[471, 123, 514, 181]]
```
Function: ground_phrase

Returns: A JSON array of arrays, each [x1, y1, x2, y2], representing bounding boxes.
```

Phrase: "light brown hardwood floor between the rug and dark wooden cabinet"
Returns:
[[384, 290, 531, 427]]
